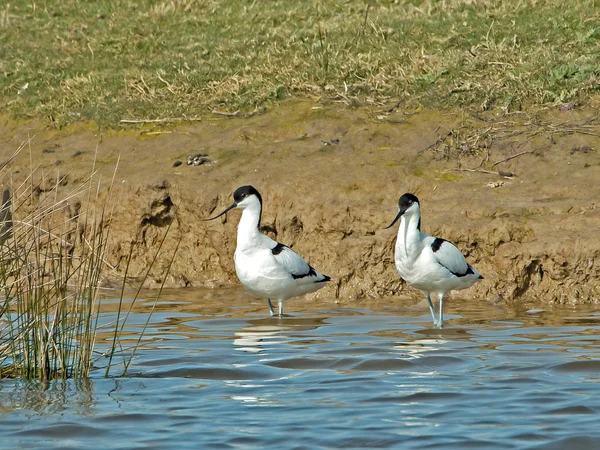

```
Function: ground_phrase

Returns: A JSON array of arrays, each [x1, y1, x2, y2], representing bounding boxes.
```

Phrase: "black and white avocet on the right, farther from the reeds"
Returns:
[[386, 193, 483, 328]]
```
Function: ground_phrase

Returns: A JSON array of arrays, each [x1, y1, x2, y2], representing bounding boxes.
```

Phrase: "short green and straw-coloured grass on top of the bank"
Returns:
[[0, 0, 600, 126]]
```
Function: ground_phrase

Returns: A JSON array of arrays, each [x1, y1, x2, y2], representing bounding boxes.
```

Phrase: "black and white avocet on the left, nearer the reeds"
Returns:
[[205, 186, 330, 316]]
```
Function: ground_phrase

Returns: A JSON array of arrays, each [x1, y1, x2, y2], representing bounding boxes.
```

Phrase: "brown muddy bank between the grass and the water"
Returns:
[[0, 101, 600, 304]]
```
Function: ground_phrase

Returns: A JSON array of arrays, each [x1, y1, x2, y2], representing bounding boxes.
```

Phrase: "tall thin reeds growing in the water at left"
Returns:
[[0, 144, 176, 381]]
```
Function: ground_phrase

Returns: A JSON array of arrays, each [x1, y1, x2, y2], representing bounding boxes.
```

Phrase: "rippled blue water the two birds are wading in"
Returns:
[[0, 290, 600, 450]]
